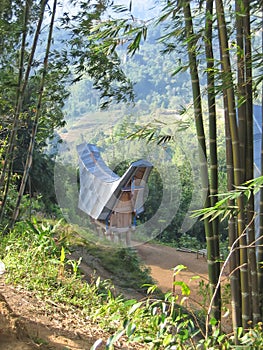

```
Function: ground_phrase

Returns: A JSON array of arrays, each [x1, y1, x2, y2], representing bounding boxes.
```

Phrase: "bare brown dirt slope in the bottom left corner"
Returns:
[[0, 278, 107, 350]]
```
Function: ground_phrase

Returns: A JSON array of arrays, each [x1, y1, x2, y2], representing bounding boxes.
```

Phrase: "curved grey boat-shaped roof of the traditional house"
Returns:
[[77, 143, 153, 220]]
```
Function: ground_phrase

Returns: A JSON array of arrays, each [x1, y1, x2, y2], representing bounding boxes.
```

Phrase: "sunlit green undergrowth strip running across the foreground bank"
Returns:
[[0, 220, 263, 350]]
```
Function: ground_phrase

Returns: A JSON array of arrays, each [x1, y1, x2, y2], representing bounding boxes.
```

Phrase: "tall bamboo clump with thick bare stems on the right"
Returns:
[[82, 0, 263, 336]]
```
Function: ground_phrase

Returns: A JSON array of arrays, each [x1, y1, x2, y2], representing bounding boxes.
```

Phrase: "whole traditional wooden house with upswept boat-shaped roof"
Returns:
[[77, 143, 153, 245]]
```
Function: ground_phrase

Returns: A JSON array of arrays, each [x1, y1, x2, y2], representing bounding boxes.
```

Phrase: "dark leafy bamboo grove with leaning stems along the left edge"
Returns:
[[0, 0, 68, 229]]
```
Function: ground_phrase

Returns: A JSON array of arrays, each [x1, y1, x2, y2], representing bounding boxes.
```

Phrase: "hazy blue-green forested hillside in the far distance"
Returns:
[[62, 22, 191, 120]]
